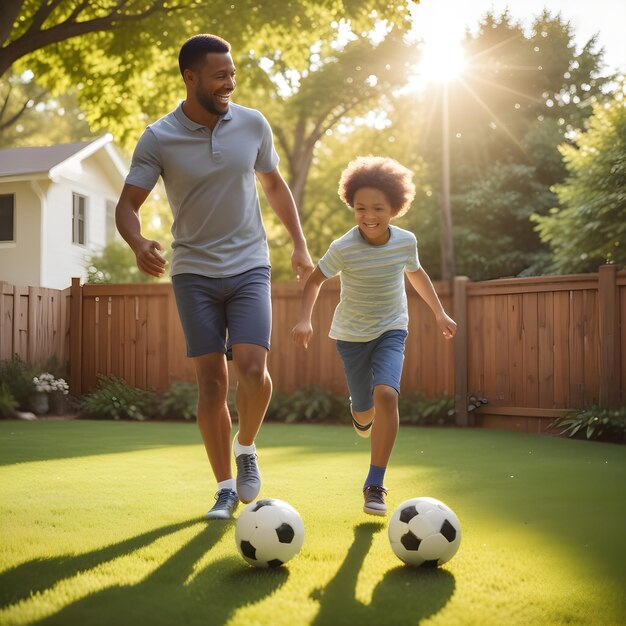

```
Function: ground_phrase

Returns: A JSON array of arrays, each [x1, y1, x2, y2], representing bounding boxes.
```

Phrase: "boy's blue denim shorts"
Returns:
[[337, 330, 408, 411]]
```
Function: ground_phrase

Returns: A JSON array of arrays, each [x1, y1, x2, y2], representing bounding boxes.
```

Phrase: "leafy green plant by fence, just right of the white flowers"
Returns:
[[79, 374, 155, 421]]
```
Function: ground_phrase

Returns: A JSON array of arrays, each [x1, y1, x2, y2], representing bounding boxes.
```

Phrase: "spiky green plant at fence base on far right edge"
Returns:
[[550, 406, 626, 443]]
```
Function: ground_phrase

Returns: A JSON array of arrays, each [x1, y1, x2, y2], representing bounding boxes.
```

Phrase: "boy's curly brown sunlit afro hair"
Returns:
[[338, 156, 415, 217]]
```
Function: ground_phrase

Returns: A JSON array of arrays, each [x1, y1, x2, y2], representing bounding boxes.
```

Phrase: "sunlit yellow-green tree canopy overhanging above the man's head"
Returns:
[[0, 0, 408, 148]]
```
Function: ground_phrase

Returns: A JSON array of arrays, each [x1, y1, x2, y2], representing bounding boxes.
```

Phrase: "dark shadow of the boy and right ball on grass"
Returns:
[[312, 522, 455, 626]]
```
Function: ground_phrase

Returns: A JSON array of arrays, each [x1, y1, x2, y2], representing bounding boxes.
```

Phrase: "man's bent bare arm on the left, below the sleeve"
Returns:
[[115, 184, 165, 278]]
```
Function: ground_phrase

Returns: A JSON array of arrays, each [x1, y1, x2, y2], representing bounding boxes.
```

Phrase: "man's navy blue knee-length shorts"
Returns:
[[172, 267, 272, 357]]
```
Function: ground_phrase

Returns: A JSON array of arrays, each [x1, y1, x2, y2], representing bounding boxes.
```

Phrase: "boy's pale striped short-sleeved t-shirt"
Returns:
[[318, 226, 420, 341]]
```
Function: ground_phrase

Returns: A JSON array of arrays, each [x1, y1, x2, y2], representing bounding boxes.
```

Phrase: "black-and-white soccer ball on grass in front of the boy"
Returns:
[[389, 498, 461, 567]]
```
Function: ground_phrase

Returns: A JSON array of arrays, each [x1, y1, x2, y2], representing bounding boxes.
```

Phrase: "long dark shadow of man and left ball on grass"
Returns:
[[15, 520, 289, 626]]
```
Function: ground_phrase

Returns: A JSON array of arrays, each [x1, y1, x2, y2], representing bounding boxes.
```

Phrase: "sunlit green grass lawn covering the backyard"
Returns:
[[0, 421, 626, 626]]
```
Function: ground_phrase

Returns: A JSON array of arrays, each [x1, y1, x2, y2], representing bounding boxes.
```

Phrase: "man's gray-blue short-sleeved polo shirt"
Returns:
[[126, 103, 278, 277]]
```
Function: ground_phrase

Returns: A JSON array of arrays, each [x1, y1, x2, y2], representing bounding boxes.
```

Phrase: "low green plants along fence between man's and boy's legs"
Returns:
[[265, 387, 350, 424]]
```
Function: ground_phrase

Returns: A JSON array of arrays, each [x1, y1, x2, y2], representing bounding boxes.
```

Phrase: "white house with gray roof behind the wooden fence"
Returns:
[[0, 134, 128, 289]]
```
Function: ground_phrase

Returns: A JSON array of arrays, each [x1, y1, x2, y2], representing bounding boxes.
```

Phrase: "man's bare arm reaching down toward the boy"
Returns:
[[256, 168, 313, 280]]
